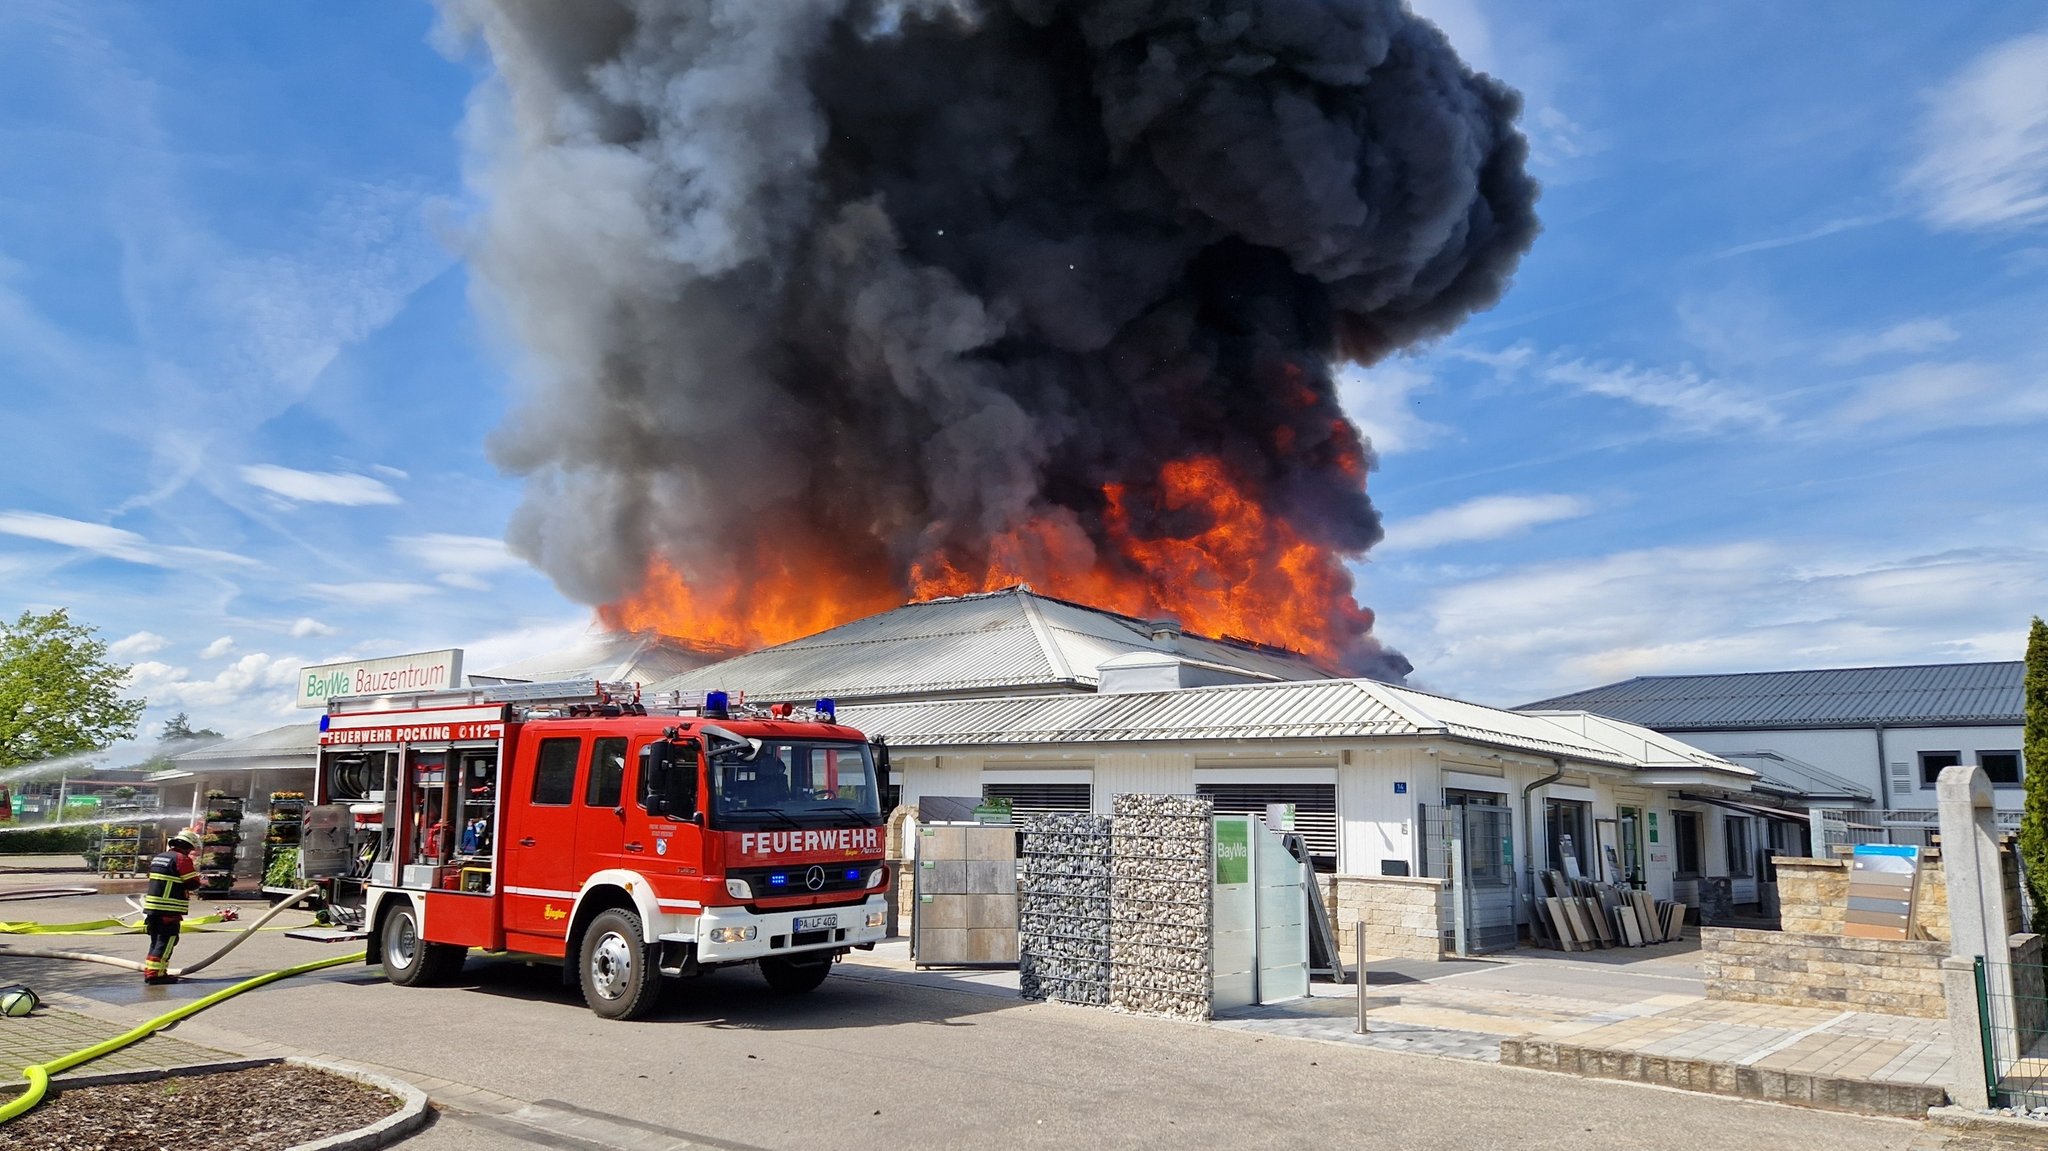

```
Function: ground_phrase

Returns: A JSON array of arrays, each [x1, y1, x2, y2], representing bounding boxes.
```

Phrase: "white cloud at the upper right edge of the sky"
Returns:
[[1907, 33, 2048, 229]]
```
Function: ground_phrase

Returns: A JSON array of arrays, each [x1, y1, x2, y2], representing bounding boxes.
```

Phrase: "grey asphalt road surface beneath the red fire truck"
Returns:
[[0, 897, 1990, 1151]]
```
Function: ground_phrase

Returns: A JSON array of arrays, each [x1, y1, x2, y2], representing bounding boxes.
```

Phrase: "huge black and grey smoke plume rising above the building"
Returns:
[[444, 0, 1536, 678]]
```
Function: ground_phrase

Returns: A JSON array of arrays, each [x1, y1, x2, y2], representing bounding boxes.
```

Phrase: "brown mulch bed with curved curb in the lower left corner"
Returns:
[[0, 1063, 399, 1151]]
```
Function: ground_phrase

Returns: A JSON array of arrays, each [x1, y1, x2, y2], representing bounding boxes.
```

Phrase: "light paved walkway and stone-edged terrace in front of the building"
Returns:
[[842, 940, 1952, 1118]]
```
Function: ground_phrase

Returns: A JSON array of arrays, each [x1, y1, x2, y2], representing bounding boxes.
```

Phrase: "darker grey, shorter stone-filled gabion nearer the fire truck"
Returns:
[[1018, 815, 1110, 1008]]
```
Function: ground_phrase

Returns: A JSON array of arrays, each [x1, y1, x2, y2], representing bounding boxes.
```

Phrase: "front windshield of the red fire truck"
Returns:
[[711, 739, 881, 827]]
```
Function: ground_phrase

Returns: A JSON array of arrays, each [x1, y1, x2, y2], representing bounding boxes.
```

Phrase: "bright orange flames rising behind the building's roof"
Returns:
[[600, 448, 1372, 668]]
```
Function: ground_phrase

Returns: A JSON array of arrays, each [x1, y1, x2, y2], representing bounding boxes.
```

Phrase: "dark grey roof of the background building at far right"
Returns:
[[1516, 659, 2023, 731]]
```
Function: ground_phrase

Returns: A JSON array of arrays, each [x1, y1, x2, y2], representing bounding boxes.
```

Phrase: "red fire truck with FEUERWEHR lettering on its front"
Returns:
[[301, 682, 889, 1020]]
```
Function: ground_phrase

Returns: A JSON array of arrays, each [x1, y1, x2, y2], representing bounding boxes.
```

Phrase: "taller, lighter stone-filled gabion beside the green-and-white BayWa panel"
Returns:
[[1110, 795, 1214, 1020]]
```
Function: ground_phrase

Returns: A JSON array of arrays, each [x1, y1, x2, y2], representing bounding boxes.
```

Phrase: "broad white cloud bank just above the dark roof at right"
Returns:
[[1382, 541, 2048, 705]]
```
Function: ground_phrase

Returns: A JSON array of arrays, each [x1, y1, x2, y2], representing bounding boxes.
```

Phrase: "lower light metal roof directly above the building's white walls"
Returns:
[[840, 680, 1753, 782]]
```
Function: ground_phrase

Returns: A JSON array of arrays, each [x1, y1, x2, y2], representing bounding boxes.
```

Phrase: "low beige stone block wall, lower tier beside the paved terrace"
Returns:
[[1700, 928, 1948, 1018]]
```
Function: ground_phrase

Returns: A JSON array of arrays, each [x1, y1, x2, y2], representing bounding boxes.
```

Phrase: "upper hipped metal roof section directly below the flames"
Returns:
[[651, 588, 1329, 705]]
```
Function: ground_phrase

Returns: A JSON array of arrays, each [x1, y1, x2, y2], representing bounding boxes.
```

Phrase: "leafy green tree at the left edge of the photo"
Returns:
[[0, 608, 143, 768]]
